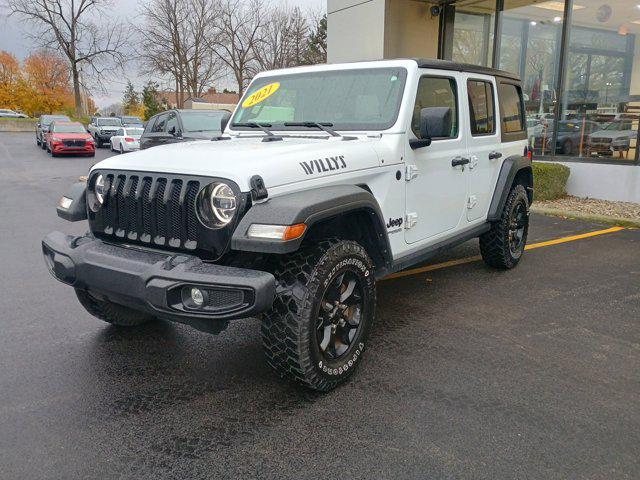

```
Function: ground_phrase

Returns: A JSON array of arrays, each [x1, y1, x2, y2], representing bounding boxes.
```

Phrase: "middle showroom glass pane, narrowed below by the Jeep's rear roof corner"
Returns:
[[498, 0, 565, 156]]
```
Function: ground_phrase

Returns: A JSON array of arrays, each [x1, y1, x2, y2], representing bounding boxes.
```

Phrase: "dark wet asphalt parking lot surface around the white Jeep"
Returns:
[[0, 133, 640, 479]]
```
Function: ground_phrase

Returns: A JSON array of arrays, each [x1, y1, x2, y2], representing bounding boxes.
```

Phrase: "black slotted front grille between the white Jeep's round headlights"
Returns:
[[94, 172, 200, 250]]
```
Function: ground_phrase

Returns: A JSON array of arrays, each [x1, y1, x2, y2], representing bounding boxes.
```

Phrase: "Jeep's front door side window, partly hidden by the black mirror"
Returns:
[[411, 77, 458, 138]]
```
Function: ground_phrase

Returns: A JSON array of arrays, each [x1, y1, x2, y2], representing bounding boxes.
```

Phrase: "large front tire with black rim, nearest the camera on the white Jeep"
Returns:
[[262, 240, 376, 391]]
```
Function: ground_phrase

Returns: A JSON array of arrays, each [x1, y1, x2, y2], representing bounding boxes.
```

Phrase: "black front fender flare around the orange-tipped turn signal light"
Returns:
[[231, 185, 392, 264]]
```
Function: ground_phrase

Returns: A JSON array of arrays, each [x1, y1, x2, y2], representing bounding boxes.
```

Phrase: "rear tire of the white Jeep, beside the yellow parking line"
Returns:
[[480, 185, 529, 270]]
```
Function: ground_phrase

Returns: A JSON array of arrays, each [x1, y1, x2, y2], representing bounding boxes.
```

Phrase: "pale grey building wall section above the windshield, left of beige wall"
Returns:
[[327, 0, 385, 63]]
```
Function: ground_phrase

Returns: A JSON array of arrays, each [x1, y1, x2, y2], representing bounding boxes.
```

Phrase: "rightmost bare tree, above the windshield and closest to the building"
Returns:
[[254, 7, 309, 70]]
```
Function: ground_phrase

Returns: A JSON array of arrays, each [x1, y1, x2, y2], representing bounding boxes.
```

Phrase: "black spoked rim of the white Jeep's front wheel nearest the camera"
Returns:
[[316, 270, 363, 360]]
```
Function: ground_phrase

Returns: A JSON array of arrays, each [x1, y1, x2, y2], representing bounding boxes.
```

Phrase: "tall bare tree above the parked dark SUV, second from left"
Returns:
[[136, 0, 222, 107]]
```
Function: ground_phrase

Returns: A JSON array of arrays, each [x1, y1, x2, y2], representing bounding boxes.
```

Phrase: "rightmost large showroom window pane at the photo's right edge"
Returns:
[[556, 0, 640, 162]]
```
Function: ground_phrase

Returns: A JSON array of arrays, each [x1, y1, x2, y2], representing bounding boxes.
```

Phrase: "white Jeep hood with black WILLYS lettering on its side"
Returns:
[[92, 137, 379, 192]]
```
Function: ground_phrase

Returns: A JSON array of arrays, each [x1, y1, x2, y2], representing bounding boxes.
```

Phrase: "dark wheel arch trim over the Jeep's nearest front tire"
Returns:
[[231, 185, 392, 269]]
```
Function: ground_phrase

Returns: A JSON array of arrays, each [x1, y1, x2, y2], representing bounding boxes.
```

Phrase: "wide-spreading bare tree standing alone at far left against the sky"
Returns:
[[7, 0, 126, 115]]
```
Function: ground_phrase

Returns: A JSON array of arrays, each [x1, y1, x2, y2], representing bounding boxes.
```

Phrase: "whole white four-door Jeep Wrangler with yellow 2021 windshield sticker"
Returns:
[[42, 60, 533, 390]]
